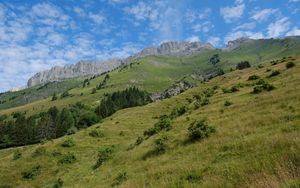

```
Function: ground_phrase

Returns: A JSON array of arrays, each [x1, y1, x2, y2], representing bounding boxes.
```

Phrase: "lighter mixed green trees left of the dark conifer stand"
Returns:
[[0, 103, 100, 148]]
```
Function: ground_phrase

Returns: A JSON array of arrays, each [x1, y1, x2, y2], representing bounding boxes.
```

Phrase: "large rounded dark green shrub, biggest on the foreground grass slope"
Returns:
[[188, 119, 215, 141]]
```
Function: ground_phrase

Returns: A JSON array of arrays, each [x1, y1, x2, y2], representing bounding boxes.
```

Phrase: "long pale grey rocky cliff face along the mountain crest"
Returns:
[[27, 42, 214, 87]]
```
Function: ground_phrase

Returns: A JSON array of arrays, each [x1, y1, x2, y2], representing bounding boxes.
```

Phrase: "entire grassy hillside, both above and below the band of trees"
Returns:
[[0, 55, 300, 187]]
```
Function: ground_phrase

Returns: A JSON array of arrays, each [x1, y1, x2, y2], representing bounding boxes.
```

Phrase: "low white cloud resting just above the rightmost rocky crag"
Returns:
[[224, 31, 264, 44]]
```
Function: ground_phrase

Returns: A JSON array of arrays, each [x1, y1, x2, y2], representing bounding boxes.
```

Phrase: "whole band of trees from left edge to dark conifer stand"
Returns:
[[0, 87, 151, 148]]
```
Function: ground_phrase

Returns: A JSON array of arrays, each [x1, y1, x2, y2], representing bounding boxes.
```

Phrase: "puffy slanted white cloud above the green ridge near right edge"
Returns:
[[267, 17, 291, 37]]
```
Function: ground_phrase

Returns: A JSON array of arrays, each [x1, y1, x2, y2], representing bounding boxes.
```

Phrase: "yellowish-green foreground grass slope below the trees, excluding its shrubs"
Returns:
[[0, 59, 300, 187]]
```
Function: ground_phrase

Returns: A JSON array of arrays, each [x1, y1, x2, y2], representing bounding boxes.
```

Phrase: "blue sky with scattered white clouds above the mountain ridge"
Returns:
[[0, 0, 300, 92]]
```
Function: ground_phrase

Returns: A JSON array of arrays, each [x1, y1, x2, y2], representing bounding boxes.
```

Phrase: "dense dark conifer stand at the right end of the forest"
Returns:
[[96, 87, 151, 118]]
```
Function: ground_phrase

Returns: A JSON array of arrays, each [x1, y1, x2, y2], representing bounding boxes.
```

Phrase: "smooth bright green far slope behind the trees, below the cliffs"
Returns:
[[0, 39, 300, 115]]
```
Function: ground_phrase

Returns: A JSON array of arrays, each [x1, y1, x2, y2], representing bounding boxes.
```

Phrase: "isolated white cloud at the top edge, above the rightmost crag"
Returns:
[[220, 1, 245, 23]]
